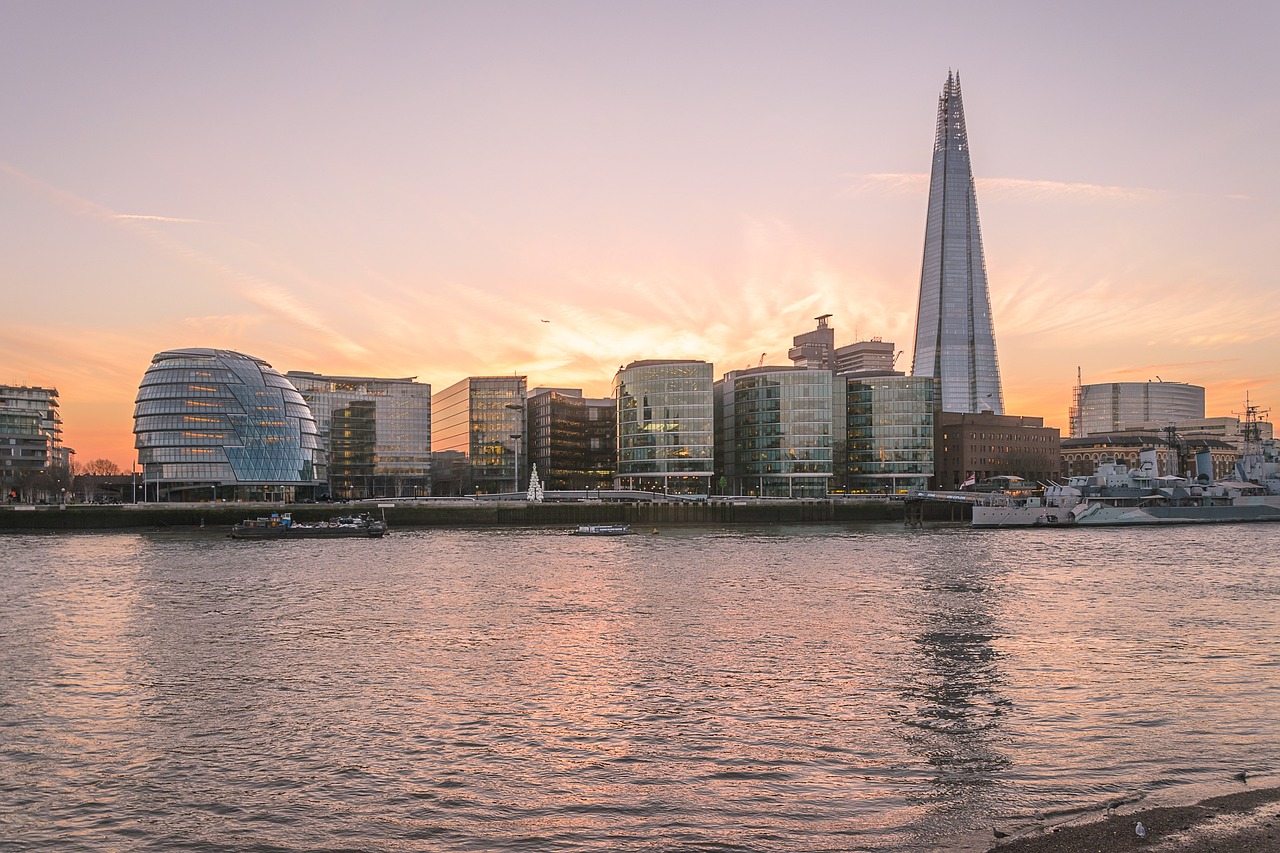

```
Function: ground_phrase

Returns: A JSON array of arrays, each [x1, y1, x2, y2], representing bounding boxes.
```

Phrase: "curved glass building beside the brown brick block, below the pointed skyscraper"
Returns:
[[841, 377, 937, 492]]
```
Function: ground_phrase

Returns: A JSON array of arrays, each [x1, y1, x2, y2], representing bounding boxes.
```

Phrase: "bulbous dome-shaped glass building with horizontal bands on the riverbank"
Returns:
[[133, 348, 324, 501]]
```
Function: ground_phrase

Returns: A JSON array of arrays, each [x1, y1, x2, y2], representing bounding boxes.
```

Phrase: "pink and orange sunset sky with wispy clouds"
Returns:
[[0, 0, 1280, 470]]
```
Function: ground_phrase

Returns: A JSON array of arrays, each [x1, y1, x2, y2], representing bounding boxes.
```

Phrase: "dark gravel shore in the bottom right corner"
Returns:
[[991, 788, 1280, 853]]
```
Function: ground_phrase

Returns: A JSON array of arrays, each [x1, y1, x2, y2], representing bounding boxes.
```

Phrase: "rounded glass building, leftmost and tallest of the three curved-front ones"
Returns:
[[613, 361, 716, 494]]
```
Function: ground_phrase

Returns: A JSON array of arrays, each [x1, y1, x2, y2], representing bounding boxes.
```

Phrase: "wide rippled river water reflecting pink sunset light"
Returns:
[[0, 525, 1280, 852]]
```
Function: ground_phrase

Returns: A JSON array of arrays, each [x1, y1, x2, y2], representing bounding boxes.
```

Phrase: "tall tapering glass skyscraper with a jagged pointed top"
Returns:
[[911, 73, 1005, 415]]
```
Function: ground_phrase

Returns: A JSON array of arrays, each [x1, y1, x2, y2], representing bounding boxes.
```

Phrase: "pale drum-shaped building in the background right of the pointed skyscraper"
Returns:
[[1071, 382, 1204, 438]]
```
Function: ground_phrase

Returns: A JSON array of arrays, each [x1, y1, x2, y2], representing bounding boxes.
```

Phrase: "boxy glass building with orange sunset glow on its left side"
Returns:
[[431, 377, 529, 494]]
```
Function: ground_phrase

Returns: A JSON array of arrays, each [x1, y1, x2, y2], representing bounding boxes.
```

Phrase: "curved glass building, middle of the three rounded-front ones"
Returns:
[[716, 368, 832, 497]]
